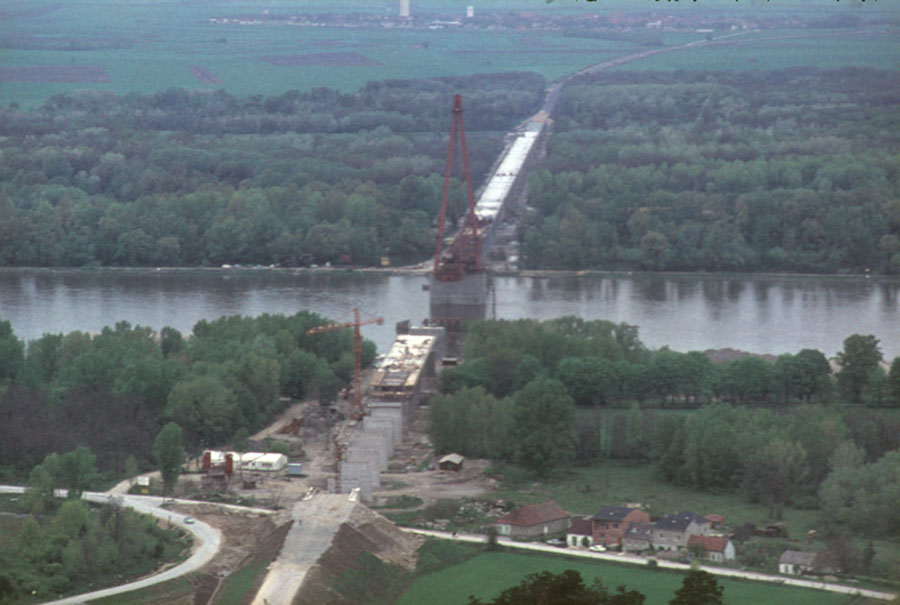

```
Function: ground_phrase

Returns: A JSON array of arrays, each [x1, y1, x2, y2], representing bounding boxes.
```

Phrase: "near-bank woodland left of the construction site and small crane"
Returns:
[[0, 312, 375, 487]]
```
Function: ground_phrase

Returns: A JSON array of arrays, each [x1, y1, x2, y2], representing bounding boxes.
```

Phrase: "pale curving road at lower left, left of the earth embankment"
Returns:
[[0, 485, 273, 605]]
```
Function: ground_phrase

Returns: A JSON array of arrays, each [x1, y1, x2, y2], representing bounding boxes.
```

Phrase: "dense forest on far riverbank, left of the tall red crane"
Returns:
[[0, 74, 544, 266]]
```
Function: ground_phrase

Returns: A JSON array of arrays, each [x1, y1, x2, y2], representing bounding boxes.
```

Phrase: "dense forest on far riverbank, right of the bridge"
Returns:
[[522, 68, 900, 273]]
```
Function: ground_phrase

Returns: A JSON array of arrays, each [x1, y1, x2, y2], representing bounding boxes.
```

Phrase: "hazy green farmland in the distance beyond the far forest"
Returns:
[[0, 0, 898, 106]]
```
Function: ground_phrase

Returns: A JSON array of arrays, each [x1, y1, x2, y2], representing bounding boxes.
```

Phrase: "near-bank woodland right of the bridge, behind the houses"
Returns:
[[429, 317, 900, 564]]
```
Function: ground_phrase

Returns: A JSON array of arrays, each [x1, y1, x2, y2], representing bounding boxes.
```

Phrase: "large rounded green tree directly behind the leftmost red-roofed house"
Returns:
[[512, 377, 575, 476]]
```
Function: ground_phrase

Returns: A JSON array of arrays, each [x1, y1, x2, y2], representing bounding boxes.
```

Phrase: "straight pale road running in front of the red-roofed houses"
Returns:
[[402, 527, 897, 601]]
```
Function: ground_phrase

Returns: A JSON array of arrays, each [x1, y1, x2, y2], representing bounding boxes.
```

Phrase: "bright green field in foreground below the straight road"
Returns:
[[396, 553, 872, 605]]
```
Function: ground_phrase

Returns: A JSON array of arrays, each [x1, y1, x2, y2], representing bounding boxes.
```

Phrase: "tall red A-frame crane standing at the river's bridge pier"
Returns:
[[434, 95, 482, 281]]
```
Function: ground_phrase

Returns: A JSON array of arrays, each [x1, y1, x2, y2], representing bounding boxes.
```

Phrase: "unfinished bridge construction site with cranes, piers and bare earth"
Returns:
[[126, 96, 546, 605]]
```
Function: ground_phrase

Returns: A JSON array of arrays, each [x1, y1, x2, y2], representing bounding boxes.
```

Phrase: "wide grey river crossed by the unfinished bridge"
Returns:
[[0, 269, 900, 359]]
